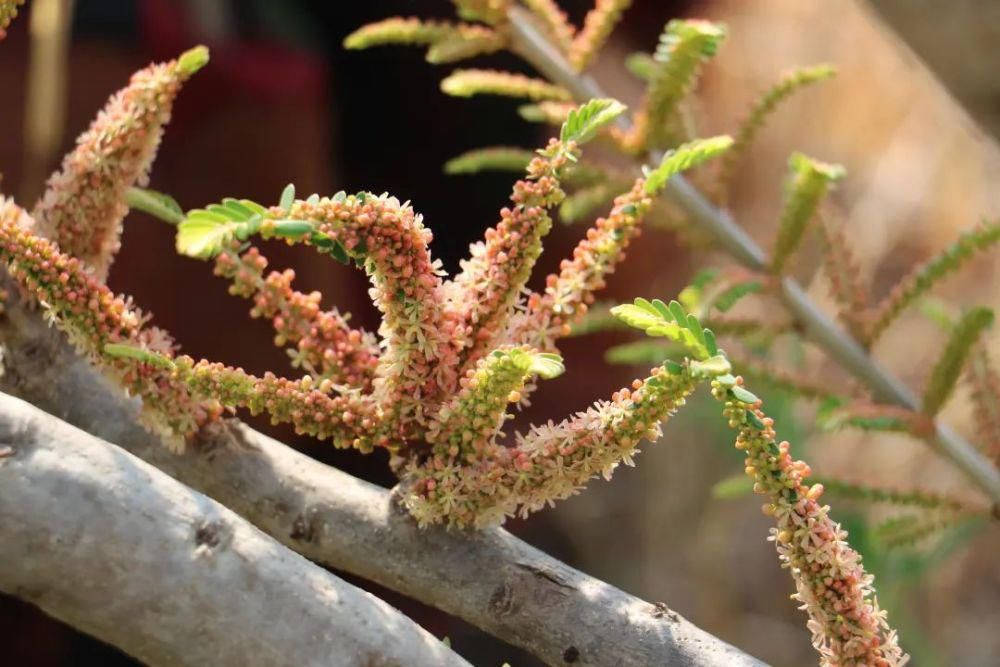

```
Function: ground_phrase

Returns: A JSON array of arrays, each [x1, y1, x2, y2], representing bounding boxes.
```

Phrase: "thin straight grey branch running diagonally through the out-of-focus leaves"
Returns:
[[508, 6, 1000, 505]]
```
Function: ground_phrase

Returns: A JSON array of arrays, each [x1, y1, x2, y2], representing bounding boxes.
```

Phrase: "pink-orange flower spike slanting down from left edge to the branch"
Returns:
[[0, 198, 221, 447]]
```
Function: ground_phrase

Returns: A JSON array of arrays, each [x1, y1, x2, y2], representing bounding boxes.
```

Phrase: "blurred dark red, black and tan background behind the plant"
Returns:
[[0, 0, 1000, 667]]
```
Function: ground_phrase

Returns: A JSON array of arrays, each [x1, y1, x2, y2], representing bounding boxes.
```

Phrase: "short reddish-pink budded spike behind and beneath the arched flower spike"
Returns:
[[215, 248, 378, 389]]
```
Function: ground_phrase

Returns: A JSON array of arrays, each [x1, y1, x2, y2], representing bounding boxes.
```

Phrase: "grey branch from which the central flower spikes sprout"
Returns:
[[0, 289, 762, 666]]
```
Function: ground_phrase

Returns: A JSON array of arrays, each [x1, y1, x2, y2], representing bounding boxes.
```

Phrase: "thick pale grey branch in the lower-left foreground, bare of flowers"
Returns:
[[0, 394, 468, 665]]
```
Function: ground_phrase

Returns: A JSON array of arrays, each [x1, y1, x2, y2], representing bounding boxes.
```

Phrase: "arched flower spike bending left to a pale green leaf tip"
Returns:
[[177, 192, 450, 434]]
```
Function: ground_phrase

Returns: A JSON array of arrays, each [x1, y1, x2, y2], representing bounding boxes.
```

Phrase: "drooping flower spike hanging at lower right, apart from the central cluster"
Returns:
[[712, 379, 909, 667]]
